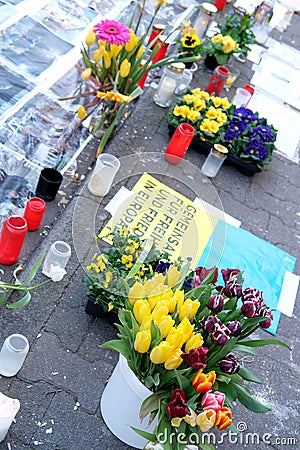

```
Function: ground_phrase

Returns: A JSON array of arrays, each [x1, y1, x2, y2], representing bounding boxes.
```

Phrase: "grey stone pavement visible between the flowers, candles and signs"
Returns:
[[0, 3, 300, 450]]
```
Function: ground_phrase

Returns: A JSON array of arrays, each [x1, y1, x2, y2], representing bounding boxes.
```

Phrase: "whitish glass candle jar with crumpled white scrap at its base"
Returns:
[[42, 241, 71, 278]]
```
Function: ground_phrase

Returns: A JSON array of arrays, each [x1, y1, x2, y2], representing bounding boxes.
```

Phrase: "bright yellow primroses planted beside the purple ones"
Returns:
[[167, 88, 235, 144]]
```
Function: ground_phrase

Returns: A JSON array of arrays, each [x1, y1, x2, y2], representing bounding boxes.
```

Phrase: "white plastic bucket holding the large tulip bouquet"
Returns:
[[101, 355, 157, 449]]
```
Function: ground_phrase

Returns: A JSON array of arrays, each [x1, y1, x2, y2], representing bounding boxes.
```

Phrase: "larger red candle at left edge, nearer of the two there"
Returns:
[[0, 216, 27, 266]]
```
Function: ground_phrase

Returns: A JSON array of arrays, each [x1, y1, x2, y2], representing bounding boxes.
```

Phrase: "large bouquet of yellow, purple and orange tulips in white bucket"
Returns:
[[102, 267, 288, 450]]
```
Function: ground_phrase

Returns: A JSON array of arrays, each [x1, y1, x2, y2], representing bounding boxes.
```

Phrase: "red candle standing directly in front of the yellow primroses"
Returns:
[[165, 123, 195, 164]]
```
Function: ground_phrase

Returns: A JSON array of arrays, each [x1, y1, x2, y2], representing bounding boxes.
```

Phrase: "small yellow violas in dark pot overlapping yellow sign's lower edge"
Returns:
[[83, 227, 181, 323]]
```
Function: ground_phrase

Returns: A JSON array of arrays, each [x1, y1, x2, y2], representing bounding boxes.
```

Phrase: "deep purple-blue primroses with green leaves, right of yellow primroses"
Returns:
[[224, 107, 277, 169]]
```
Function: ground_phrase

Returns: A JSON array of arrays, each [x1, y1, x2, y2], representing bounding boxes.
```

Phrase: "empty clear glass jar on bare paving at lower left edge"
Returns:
[[0, 334, 29, 377]]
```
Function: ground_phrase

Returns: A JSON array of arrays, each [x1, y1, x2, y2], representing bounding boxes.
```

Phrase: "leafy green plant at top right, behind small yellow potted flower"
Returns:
[[218, 9, 256, 56]]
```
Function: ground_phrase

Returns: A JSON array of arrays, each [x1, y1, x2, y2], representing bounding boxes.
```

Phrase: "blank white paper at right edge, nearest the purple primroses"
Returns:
[[249, 89, 300, 161]]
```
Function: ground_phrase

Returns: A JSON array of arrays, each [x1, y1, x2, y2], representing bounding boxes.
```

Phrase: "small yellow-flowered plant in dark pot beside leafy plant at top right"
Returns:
[[204, 33, 239, 70]]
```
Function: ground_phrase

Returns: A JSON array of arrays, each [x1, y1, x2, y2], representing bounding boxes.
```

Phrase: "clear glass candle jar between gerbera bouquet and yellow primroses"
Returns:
[[153, 62, 185, 108]]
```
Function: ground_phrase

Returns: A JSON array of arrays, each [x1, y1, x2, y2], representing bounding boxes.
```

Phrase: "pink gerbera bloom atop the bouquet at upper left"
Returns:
[[94, 20, 130, 45]]
